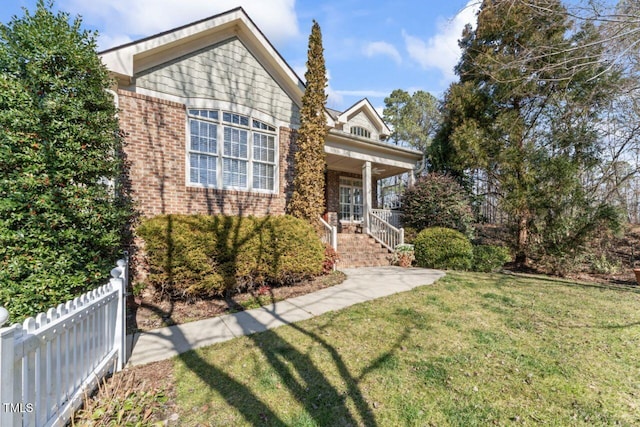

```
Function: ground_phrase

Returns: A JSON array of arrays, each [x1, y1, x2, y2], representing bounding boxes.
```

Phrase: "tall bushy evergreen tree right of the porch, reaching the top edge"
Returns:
[[431, 0, 615, 270]]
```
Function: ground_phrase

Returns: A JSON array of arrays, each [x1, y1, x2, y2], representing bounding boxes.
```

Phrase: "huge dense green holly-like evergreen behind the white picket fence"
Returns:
[[0, 0, 130, 321]]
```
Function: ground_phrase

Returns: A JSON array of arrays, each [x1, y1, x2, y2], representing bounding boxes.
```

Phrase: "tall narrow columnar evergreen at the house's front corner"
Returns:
[[289, 21, 327, 222]]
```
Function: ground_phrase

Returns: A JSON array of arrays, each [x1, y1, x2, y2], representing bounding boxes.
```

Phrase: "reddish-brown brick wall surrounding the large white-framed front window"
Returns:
[[118, 90, 296, 217]]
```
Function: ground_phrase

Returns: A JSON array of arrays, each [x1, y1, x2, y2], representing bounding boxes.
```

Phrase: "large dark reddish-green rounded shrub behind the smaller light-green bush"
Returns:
[[402, 173, 474, 238]]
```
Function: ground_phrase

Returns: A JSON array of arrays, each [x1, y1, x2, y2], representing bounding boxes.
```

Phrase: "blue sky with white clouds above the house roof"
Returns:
[[0, 0, 478, 110]]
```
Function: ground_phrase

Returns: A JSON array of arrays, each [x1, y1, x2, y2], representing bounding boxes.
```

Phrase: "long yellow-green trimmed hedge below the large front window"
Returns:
[[137, 215, 324, 299]]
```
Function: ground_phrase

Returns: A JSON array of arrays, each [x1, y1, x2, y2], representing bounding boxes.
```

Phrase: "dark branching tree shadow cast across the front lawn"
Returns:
[[132, 278, 422, 426]]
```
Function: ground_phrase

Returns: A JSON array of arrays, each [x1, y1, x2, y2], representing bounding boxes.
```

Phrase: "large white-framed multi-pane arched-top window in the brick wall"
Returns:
[[188, 109, 278, 192]]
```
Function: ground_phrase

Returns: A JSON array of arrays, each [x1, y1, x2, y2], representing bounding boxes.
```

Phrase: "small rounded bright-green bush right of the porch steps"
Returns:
[[414, 227, 473, 270]]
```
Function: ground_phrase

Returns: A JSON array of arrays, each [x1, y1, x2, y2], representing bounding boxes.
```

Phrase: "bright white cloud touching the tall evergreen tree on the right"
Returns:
[[402, 0, 480, 81]]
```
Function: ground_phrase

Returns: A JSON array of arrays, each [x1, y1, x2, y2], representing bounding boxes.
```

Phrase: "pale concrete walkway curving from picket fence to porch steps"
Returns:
[[128, 267, 444, 366]]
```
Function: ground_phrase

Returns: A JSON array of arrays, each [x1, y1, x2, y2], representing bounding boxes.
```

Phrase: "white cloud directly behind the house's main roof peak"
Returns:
[[61, 0, 300, 49]]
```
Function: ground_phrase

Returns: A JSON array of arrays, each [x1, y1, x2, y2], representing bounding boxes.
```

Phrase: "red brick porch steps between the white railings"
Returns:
[[338, 233, 391, 268]]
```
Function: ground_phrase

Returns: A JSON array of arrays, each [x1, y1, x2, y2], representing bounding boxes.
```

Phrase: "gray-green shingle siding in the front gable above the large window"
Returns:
[[135, 37, 300, 126]]
